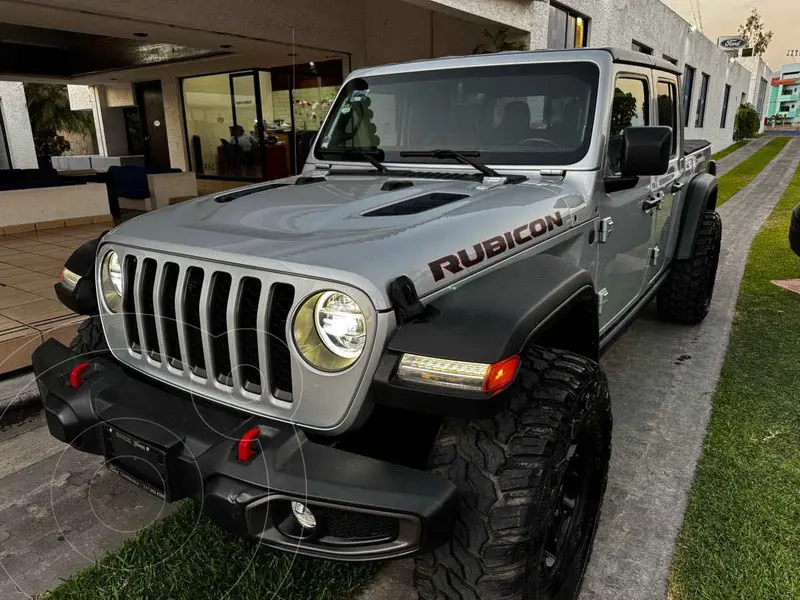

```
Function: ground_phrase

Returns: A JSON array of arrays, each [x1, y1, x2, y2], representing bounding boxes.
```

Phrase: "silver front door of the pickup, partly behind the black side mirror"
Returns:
[[597, 71, 653, 333]]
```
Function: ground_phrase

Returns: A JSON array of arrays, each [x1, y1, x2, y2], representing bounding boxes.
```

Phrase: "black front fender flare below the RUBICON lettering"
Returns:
[[371, 254, 599, 416]]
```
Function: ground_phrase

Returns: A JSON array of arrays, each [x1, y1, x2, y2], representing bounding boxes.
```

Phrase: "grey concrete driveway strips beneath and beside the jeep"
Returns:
[[0, 140, 800, 600]]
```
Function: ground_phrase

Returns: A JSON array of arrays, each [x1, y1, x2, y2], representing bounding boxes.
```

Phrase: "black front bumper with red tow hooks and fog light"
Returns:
[[33, 340, 456, 560]]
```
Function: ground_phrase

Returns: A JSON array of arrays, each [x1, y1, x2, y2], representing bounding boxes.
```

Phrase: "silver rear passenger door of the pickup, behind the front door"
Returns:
[[647, 71, 683, 286]]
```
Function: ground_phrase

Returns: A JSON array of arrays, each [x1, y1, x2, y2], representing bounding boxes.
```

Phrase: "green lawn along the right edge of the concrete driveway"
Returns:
[[670, 157, 800, 600]]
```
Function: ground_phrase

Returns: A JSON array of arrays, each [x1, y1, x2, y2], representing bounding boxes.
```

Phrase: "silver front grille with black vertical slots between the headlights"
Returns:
[[113, 248, 295, 409]]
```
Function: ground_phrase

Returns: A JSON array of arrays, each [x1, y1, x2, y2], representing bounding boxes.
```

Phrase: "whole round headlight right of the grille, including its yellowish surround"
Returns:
[[294, 291, 367, 371]]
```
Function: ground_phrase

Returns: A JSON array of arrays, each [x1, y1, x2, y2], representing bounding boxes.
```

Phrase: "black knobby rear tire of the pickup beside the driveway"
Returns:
[[656, 210, 722, 325]]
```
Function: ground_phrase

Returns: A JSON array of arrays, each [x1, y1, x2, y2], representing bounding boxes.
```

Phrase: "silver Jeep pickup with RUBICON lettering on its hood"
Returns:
[[33, 49, 721, 600]]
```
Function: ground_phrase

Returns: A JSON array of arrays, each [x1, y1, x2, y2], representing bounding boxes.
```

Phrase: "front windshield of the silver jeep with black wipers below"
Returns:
[[314, 62, 599, 165]]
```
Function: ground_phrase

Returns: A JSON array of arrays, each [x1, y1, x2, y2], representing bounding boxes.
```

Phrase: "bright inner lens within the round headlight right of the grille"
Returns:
[[314, 292, 367, 358]]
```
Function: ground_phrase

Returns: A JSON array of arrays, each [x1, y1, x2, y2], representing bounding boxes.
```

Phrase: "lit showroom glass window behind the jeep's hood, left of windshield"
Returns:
[[181, 60, 342, 180]]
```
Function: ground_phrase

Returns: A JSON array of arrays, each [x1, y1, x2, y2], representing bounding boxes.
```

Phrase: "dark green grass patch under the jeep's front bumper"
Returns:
[[42, 502, 377, 600]]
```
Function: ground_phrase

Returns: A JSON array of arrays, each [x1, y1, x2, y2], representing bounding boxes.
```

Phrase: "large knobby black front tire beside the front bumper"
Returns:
[[414, 347, 611, 600]]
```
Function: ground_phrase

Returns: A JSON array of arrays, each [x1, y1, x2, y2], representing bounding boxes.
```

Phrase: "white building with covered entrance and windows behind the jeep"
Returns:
[[0, 0, 768, 180]]
